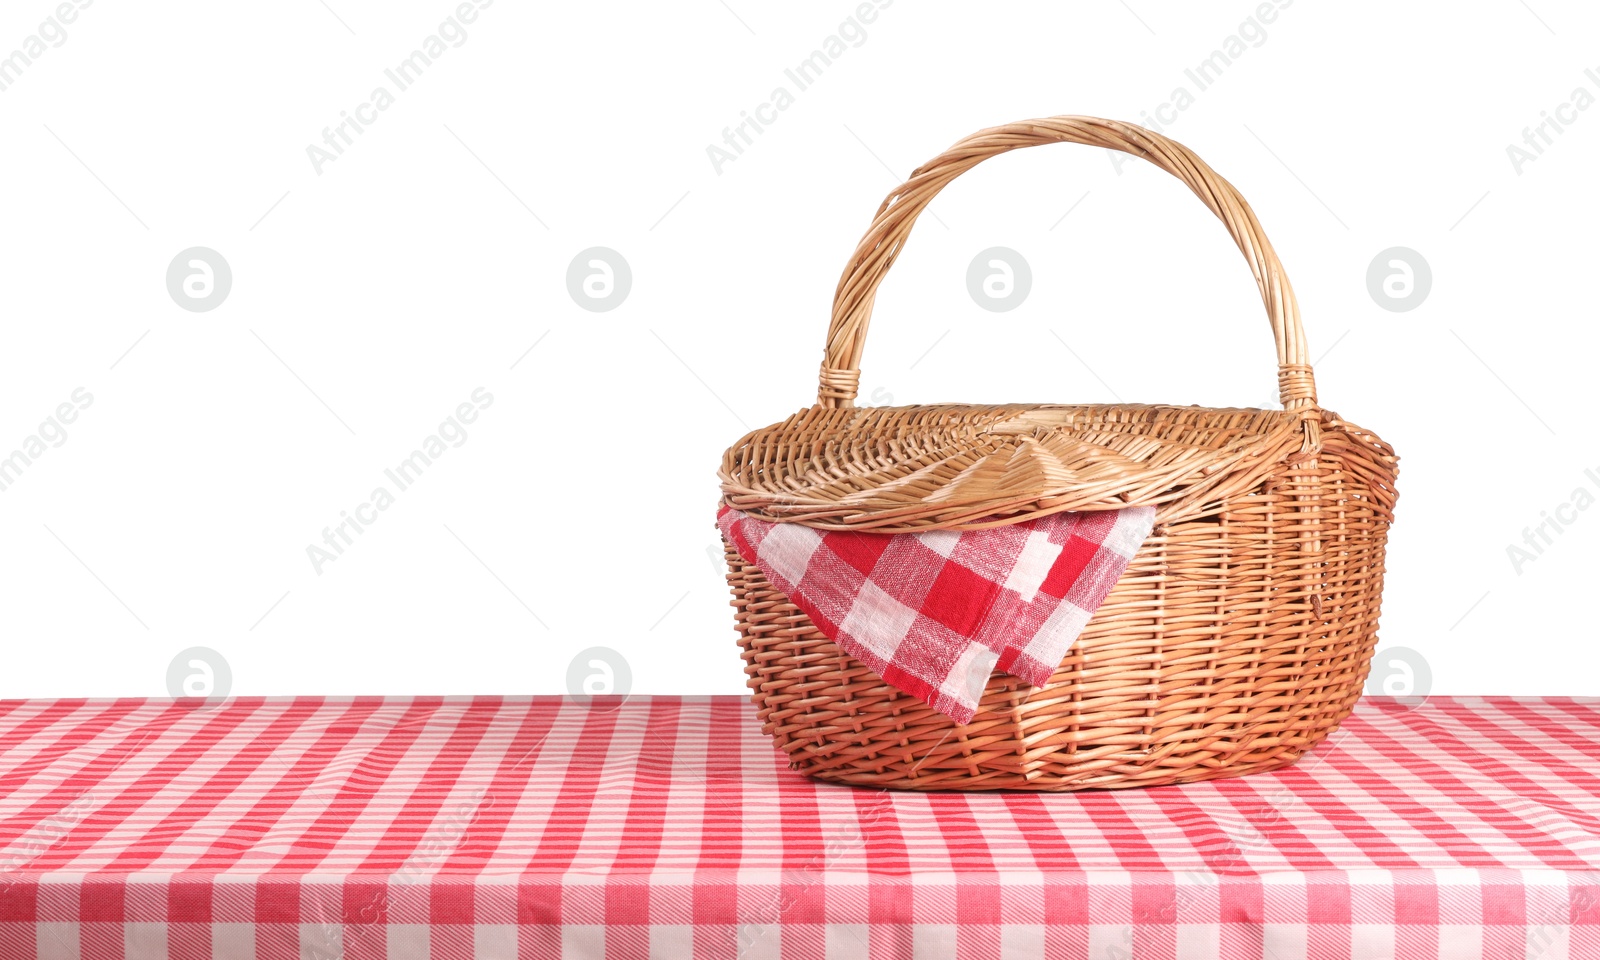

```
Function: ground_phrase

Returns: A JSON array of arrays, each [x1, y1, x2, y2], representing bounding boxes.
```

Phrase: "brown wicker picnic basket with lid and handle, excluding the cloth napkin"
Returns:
[[720, 117, 1397, 790]]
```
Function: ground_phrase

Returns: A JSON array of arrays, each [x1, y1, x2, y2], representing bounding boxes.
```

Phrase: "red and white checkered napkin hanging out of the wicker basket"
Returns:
[[717, 506, 1155, 723]]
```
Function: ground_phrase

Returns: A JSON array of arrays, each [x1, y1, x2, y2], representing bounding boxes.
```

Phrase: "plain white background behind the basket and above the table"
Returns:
[[0, 0, 1600, 696]]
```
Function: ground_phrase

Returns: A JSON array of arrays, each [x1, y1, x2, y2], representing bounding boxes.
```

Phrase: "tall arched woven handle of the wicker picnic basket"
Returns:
[[816, 117, 1320, 450]]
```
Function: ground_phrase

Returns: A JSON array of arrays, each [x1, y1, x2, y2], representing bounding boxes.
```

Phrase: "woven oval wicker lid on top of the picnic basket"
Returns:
[[720, 405, 1304, 533]]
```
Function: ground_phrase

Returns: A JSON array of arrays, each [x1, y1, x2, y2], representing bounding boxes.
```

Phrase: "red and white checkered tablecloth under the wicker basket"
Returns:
[[0, 698, 1600, 960]]
